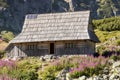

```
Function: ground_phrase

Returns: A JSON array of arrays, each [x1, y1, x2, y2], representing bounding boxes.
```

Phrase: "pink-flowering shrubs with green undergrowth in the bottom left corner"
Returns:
[[0, 60, 38, 80]]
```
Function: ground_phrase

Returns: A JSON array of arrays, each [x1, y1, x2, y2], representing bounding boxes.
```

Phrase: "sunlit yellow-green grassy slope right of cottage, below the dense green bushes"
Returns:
[[95, 29, 120, 55]]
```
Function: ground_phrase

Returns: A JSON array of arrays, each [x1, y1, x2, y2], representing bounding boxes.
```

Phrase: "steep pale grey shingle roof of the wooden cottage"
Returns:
[[11, 11, 98, 43]]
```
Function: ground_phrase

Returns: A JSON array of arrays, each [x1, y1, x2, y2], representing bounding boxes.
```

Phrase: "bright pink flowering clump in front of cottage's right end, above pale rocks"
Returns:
[[70, 56, 107, 78]]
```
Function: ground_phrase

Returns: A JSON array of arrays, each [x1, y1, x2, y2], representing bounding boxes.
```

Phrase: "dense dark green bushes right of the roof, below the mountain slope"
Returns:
[[93, 17, 120, 31]]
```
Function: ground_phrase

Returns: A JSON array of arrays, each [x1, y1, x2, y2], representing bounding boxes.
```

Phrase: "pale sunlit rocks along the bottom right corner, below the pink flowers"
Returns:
[[56, 60, 120, 80]]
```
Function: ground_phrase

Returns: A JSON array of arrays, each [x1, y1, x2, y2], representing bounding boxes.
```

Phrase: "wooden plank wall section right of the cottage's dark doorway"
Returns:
[[55, 41, 95, 55]]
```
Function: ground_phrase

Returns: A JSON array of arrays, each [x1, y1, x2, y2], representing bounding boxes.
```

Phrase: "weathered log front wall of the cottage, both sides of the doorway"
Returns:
[[8, 40, 95, 57]]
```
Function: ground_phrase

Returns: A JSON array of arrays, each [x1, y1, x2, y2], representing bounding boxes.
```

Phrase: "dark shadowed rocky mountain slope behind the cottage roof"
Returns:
[[0, 0, 120, 33]]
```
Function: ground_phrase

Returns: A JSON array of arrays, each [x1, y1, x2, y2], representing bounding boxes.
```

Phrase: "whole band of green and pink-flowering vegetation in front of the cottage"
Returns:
[[0, 56, 120, 80]]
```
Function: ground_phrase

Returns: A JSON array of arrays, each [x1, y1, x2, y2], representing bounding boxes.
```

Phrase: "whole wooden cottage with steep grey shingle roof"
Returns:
[[7, 11, 99, 57]]
